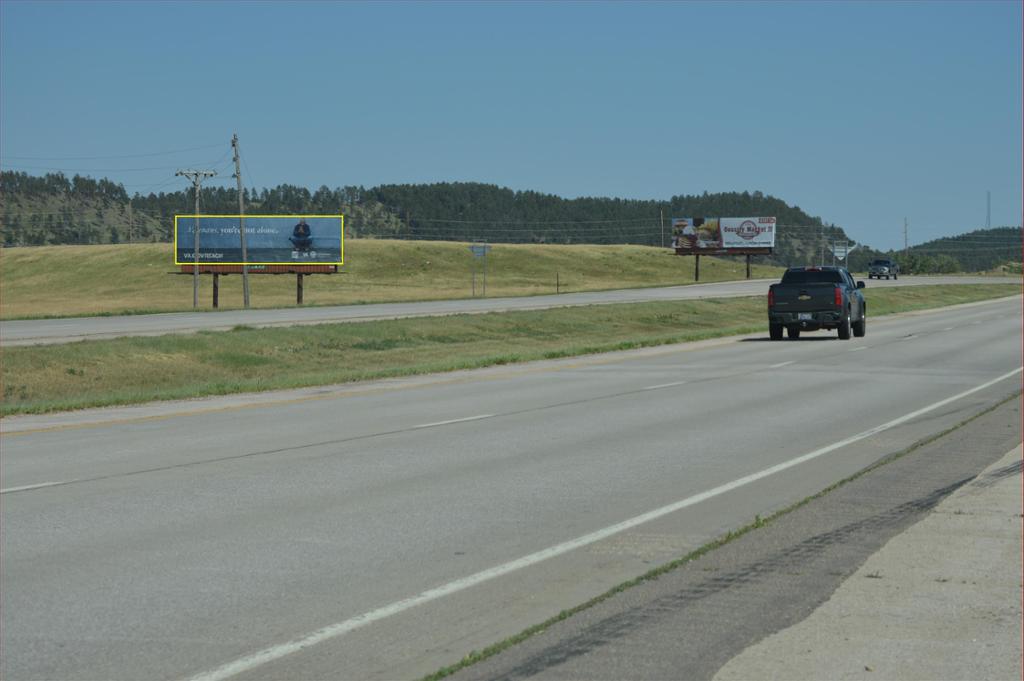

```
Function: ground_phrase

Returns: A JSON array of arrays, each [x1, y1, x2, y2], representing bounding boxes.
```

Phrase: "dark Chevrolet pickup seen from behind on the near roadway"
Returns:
[[768, 266, 867, 340]]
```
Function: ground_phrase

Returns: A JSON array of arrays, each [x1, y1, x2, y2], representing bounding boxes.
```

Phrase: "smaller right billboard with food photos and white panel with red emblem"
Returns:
[[672, 217, 775, 255]]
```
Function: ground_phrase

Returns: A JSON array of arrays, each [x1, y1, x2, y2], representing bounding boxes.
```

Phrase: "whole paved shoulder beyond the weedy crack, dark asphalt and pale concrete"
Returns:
[[452, 398, 1021, 681]]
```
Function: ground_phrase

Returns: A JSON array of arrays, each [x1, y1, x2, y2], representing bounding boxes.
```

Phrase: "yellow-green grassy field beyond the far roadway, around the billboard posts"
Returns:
[[0, 239, 782, 320]]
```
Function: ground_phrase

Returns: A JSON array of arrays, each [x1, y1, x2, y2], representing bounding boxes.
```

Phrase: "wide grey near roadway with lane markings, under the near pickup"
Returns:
[[0, 292, 1022, 680]]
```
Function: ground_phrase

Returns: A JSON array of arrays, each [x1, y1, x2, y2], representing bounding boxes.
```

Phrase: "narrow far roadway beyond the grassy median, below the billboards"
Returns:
[[0, 276, 1007, 346]]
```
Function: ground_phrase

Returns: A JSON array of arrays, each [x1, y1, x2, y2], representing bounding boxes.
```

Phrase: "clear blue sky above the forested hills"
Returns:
[[0, 0, 1024, 248]]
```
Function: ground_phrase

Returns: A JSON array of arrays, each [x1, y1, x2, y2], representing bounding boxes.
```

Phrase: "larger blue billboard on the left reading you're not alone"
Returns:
[[174, 215, 345, 265]]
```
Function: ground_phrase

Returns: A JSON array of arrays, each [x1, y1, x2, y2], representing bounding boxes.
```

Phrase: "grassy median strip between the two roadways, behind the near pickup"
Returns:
[[0, 285, 1020, 415]]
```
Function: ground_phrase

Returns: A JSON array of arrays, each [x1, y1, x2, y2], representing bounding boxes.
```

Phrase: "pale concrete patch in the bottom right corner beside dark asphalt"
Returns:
[[715, 445, 1024, 681]]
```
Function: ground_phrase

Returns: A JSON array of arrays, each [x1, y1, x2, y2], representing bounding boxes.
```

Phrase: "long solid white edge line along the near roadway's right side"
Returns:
[[190, 367, 1024, 681]]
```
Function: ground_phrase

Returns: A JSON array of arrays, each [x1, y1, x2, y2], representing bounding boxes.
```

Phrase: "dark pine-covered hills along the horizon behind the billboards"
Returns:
[[0, 171, 1021, 271]]
